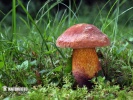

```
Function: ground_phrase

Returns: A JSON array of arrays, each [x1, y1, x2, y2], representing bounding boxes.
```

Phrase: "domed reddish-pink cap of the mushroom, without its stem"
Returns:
[[56, 23, 110, 48]]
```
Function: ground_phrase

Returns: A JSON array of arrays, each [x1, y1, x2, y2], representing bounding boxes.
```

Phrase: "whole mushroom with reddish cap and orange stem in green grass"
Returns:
[[56, 23, 110, 87]]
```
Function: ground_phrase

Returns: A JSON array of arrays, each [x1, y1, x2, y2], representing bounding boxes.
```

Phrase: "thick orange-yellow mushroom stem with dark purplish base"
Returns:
[[72, 48, 101, 87]]
